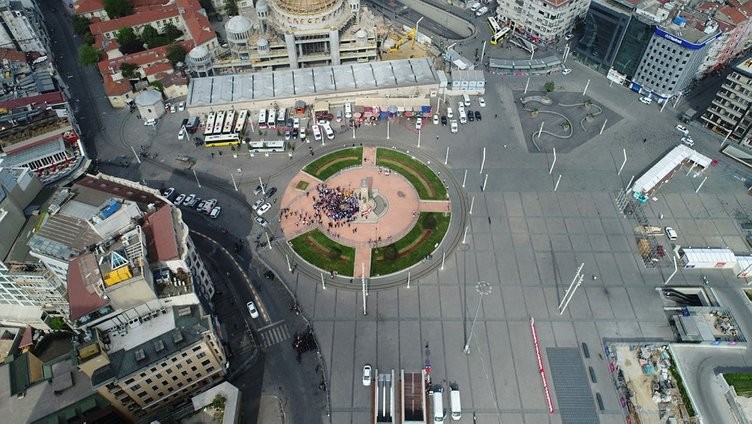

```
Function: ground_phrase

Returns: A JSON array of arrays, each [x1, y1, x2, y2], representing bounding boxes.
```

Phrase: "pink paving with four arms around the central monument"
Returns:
[[278, 147, 451, 278]]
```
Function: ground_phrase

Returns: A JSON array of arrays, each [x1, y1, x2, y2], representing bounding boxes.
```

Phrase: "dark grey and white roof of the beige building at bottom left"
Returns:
[[92, 305, 211, 388]]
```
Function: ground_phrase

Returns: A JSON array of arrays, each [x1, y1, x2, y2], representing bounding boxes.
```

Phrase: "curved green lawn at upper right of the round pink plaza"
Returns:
[[376, 149, 447, 200]]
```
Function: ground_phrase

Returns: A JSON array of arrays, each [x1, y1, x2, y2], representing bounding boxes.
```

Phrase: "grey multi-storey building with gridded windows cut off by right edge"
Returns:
[[700, 57, 752, 147]]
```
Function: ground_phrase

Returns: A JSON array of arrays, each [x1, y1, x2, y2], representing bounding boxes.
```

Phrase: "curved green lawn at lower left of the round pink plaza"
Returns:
[[290, 229, 355, 277]]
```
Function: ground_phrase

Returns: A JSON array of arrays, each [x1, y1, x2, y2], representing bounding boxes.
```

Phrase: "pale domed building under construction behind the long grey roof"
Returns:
[[186, 0, 377, 76]]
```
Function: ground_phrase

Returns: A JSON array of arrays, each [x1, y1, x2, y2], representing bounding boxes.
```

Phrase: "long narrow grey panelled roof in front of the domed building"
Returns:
[[188, 58, 439, 106]]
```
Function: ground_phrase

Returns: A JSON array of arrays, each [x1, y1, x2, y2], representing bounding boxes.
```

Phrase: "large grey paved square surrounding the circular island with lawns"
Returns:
[[94, 56, 752, 424]]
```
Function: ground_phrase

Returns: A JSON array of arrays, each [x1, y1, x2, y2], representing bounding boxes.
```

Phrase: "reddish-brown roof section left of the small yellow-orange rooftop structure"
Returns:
[[68, 252, 107, 320]]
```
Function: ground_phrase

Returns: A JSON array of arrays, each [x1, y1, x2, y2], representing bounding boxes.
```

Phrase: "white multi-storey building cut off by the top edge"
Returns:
[[496, 0, 590, 44]]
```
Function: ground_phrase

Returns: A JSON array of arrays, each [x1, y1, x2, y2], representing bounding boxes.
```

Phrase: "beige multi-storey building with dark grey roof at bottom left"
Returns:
[[76, 305, 228, 421]]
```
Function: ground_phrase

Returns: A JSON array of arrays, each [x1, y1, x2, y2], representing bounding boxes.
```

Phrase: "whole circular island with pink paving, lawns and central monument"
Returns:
[[279, 147, 452, 278]]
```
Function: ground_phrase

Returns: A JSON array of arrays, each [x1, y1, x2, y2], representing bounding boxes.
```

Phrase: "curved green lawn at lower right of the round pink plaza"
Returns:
[[371, 212, 451, 276]]
